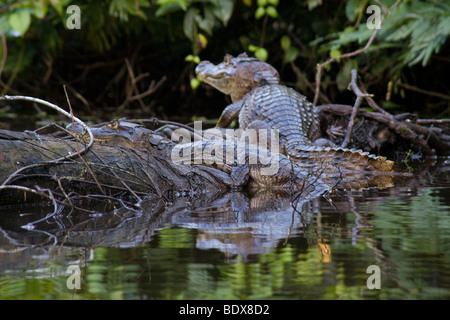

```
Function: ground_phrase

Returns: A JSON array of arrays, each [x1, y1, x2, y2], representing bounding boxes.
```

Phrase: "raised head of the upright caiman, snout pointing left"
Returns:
[[195, 53, 280, 102]]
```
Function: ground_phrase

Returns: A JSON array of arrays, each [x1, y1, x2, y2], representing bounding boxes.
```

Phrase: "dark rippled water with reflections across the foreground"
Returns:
[[0, 159, 450, 299]]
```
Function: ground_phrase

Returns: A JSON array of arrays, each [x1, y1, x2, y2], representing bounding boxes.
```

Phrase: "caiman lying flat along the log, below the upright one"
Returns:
[[68, 120, 330, 198]]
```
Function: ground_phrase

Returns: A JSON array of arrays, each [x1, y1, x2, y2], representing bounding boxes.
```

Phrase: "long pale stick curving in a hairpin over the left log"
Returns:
[[0, 95, 94, 186]]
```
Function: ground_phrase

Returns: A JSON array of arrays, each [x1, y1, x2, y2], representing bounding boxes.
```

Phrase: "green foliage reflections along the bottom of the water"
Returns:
[[0, 189, 450, 299]]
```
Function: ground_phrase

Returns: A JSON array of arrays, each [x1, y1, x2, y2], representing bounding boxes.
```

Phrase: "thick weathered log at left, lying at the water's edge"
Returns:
[[0, 127, 234, 203]]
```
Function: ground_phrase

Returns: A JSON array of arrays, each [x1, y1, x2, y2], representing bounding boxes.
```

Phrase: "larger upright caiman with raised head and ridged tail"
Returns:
[[195, 53, 394, 188]]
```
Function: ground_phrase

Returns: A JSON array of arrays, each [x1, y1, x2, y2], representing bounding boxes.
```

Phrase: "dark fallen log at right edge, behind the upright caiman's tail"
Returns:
[[317, 104, 450, 161]]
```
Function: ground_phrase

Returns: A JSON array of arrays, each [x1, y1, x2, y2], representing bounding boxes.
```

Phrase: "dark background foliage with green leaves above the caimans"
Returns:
[[0, 0, 450, 125]]
